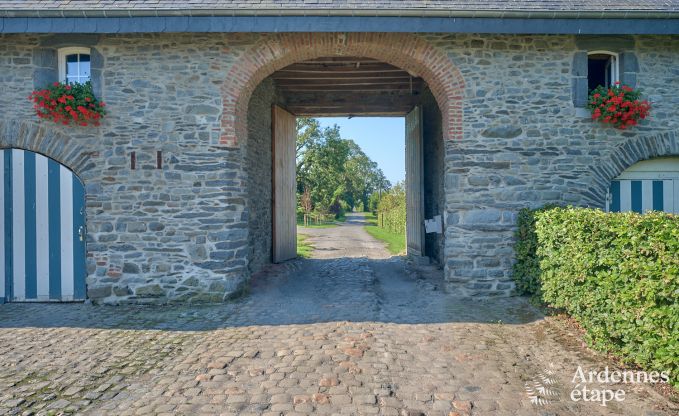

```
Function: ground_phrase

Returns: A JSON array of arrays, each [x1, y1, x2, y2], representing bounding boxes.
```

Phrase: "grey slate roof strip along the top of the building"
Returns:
[[0, 0, 679, 15]]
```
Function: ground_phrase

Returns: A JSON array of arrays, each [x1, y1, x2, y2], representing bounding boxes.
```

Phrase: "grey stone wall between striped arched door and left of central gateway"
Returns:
[[0, 35, 258, 302]]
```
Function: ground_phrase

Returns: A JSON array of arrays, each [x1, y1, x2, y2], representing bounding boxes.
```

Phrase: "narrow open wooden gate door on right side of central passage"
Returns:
[[406, 106, 424, 257]]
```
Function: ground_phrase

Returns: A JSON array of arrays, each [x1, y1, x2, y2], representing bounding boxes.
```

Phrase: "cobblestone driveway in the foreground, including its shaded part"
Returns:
[[0, 216, 679, 416]]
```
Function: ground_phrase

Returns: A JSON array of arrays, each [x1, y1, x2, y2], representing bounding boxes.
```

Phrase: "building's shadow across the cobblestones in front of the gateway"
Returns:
[[0, 257, 542, 331]]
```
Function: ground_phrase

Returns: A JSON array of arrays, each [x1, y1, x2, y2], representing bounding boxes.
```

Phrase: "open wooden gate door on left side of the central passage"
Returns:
[[271, 105, 297, 263]]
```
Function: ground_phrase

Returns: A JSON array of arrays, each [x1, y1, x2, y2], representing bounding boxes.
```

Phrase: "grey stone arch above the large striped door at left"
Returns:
[[0, 120, 89, 176]]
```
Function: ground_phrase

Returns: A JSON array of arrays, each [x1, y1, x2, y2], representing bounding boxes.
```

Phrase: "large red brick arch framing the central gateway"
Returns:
[[220, 33, 464, 147]]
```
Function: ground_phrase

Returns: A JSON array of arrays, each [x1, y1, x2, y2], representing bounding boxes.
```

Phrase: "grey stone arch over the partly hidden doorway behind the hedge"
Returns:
[[591, 131, 679, 207]]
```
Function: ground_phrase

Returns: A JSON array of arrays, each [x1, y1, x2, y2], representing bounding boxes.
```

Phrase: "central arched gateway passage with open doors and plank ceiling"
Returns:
[[241, 56, 445, 271]]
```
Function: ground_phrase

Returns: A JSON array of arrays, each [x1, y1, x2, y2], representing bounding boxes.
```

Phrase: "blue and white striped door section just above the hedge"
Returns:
[[608, 179, 679, 214]]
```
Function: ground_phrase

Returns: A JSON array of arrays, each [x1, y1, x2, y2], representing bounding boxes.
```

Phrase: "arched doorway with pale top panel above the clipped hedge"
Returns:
[[606, 157, 679, 214]]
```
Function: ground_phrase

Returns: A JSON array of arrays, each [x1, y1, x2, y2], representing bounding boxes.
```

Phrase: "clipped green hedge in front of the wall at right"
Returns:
[[525, 208, 679, 387]]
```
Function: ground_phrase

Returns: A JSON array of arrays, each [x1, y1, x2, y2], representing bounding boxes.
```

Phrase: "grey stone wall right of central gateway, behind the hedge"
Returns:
[[428, 35, 679, 295]]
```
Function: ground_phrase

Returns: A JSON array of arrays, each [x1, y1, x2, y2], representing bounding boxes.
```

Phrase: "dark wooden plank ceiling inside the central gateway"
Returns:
[[271, 56, 426, 117]]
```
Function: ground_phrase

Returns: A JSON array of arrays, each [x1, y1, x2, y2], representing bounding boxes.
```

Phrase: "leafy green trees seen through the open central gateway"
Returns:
[[297, 118, 389, 217]]
